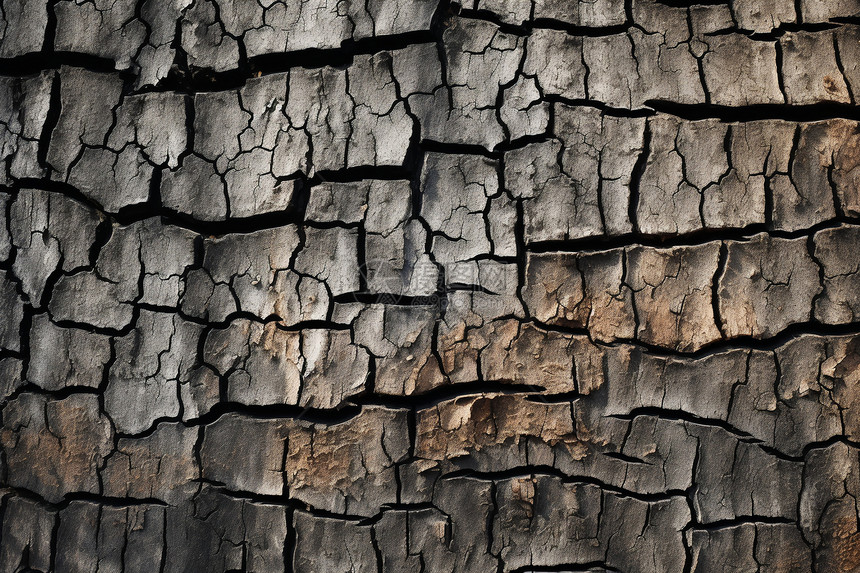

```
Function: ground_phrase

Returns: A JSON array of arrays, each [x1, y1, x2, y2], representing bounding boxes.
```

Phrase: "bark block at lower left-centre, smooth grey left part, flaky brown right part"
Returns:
[[200, 408, 408, 516]]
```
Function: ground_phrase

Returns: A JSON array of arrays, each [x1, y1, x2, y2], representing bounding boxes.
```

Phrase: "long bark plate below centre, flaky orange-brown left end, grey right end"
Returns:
[[415, 395, 695, 493]]
